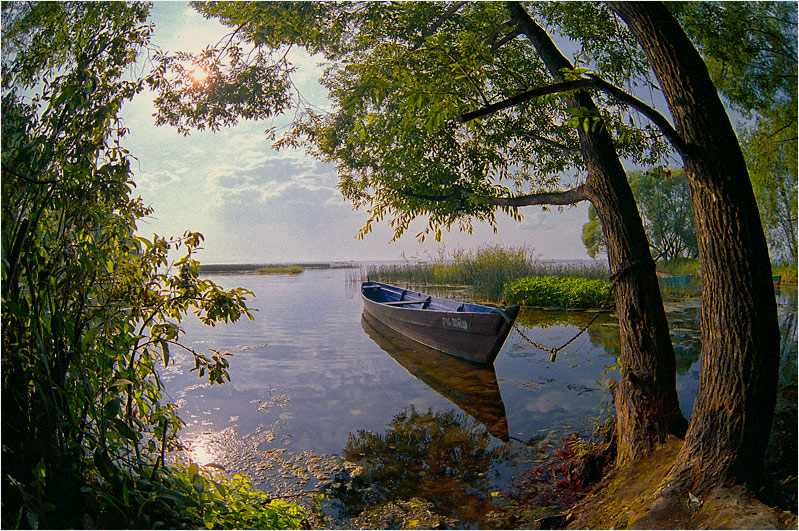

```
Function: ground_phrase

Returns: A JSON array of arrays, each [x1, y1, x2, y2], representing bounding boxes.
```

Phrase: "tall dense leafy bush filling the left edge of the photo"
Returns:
[[1, 2, 300, 528]]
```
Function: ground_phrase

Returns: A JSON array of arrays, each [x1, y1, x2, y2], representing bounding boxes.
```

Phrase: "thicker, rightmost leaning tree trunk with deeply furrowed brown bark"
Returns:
[[609, 2, 780, 492]]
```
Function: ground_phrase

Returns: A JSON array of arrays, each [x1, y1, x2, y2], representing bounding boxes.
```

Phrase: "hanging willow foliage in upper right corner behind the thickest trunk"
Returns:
[[669, 2, 799, 264]]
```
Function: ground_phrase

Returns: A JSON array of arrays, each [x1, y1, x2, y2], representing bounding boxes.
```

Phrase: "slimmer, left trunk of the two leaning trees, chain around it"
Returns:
[[509, 2, 687, 464]]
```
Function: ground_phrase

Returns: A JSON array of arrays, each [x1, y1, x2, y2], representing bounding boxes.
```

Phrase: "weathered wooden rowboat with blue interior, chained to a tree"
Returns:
[[361, 281, 519, 364]]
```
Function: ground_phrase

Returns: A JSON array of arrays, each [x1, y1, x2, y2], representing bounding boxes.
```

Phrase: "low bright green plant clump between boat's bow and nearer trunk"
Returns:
[[505, 276, 611, 309]]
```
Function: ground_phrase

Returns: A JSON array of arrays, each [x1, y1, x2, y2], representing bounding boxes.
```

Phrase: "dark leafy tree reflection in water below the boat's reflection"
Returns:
[[334, 407, 507, 521]]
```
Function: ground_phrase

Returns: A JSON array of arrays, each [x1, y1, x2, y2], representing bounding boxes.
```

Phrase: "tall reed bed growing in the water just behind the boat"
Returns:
[[366, 246, 608, 302]]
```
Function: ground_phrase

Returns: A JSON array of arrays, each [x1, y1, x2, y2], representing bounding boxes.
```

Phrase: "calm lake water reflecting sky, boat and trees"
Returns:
[[163, 269, 797, 527]]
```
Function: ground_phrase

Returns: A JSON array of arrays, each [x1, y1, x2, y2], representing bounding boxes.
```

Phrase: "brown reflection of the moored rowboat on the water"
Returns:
[[361, 312, 510, 442]]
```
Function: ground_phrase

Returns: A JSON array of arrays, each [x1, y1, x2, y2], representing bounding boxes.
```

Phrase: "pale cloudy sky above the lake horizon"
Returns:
[[122, 2, 604, 264]]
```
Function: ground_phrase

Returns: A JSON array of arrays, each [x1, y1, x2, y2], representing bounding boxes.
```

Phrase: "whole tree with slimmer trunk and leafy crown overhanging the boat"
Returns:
[[157, 2, 686, 462]]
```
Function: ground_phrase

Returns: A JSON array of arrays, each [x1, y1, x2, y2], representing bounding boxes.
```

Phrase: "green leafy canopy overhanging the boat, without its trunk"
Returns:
[[152, 2, 668, 242]]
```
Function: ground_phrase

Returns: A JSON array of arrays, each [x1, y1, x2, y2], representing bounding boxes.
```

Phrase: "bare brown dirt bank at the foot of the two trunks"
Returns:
[[566, 438, 797, 529]]
